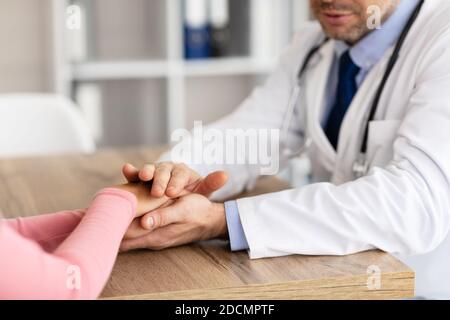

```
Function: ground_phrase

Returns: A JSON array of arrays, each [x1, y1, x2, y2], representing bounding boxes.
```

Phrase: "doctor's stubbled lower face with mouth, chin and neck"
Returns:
[[310, 0, 400, 45]]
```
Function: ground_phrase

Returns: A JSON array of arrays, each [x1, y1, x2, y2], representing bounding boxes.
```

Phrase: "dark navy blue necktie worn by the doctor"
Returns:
[[324, 51, 361, 149]]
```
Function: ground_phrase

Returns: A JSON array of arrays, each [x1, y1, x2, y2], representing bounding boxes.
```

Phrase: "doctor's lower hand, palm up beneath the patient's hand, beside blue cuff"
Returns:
[[120, 194, 228, 252]]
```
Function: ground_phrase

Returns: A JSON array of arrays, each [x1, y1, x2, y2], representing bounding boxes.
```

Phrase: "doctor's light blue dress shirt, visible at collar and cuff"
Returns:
[[225, 0, 420, 251]]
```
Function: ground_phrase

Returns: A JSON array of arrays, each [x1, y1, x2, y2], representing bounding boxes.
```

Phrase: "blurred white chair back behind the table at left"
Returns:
[[0, 94, 95, 157]]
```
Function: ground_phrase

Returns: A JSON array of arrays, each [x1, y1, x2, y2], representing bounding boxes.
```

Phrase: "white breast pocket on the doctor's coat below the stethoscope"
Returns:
[[367, 120, 401, 168]]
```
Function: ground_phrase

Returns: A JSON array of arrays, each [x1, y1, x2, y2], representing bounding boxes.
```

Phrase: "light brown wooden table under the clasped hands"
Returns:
[[0, 148, 414, 299]]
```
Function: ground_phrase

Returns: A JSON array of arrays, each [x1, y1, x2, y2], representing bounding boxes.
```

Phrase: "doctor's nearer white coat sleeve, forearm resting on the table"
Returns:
[[237, 159, 449, 258]]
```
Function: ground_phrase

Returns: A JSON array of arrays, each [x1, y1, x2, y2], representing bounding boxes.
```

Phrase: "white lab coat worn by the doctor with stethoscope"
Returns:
[[163, 0, 450, 298]]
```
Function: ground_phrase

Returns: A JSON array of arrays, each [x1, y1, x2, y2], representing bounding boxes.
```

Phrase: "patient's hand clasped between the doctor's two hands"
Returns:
[[114, 182, 171, 218]]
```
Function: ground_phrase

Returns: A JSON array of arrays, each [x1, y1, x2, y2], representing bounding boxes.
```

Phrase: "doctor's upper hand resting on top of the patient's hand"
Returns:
[[122, 162, 228, 198]]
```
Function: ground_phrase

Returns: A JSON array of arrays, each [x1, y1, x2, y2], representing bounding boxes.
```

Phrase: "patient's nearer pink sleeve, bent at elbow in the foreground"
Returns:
[[0, 188, 136, 299]]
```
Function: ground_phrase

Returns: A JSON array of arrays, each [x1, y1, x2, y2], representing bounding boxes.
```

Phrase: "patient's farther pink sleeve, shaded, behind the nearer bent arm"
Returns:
[[4, 210, 86, 252]]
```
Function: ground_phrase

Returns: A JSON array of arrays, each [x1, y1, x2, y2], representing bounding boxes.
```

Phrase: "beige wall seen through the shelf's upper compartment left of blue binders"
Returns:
[[89, 0, 165, 60]]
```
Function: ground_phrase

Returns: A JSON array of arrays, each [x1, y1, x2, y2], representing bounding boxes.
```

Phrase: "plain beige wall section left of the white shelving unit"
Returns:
[[0, 0, 51, 93]]
